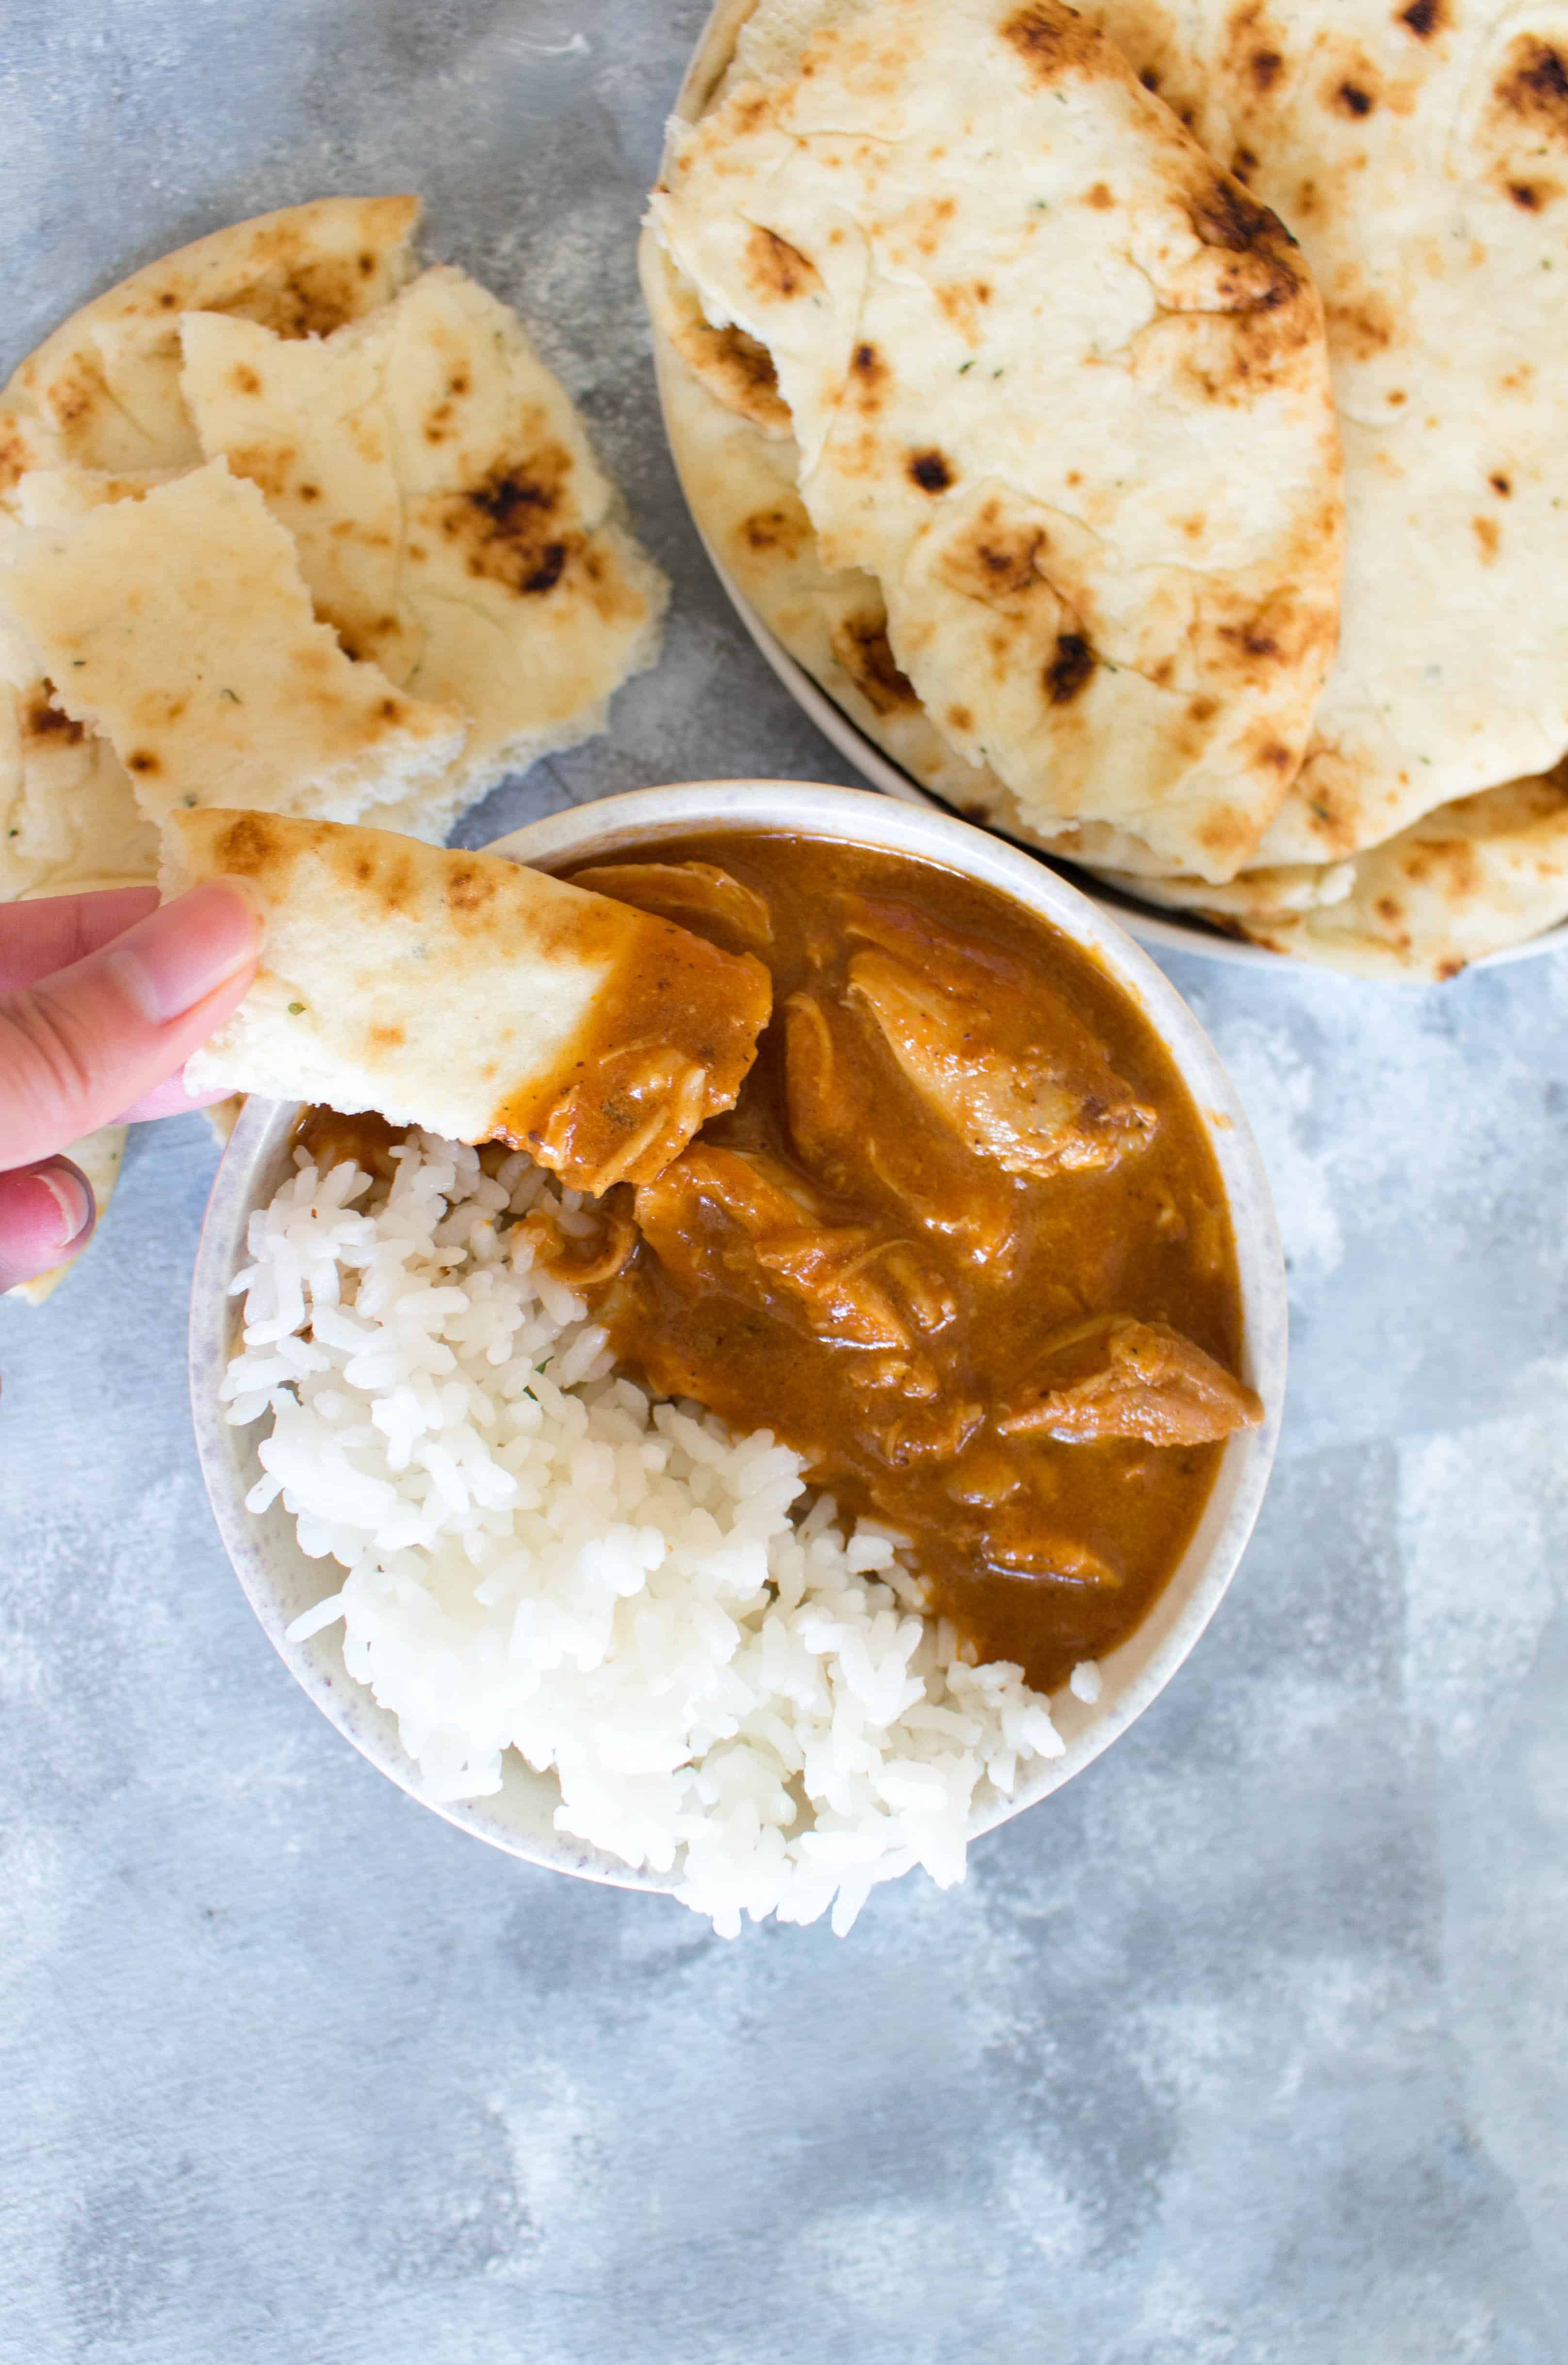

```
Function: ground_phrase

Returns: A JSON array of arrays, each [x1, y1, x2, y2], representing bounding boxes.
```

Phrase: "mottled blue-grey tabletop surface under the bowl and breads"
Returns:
[[0, 0, 1568, 2365]]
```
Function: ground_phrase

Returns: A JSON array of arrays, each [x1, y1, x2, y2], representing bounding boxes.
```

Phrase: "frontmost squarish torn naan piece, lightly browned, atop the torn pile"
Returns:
[[0, 461, 463, 821]]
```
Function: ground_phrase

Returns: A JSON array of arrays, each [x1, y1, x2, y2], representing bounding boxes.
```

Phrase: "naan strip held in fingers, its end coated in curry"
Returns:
[[163, 811, 771, 1192]]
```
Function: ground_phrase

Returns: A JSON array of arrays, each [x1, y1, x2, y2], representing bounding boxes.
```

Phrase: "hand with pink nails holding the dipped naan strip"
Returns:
[[0, 880, 260, 1289]]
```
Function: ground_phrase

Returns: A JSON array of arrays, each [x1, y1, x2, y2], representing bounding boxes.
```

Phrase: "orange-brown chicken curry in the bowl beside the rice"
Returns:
[[548, 832, 1263, 1691]]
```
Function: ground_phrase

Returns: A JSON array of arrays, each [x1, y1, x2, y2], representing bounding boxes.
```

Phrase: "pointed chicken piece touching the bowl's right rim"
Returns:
[[996, 1315, 1263, 1445]]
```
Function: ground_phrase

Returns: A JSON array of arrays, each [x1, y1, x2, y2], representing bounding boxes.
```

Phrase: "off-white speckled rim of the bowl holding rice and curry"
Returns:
[[189, 781, 1287, 1890]]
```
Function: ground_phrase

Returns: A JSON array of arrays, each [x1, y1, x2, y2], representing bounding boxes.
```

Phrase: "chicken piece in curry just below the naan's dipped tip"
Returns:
[[636, 1145, 913, 1355]]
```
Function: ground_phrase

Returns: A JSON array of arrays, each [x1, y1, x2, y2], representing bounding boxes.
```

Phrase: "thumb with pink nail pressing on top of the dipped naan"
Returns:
[[0, 880, 260, 1166]]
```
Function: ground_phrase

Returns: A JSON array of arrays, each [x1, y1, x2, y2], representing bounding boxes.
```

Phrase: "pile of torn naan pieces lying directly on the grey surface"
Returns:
[[0, 196, 667, 1305]]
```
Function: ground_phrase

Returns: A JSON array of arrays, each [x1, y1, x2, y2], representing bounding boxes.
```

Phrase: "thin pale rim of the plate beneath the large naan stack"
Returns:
[[643, 0, 1568, 991]]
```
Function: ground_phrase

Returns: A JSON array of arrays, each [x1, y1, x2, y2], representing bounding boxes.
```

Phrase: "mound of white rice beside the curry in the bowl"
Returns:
[[222, 1135, 1088, 1937]]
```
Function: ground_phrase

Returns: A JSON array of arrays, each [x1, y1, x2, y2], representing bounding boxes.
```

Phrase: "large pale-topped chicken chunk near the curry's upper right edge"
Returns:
[[849, 946, 1157, 1180]]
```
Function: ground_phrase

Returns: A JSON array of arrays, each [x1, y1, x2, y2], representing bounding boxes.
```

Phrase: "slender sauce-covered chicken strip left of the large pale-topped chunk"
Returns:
[[783, 994, 1019, 1272]]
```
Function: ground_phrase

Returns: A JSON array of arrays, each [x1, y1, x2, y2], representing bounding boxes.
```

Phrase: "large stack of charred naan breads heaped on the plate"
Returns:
[[643, 0, 1568, 977]]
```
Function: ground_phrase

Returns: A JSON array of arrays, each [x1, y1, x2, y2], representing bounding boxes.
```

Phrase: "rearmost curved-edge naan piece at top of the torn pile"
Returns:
[[0, 196, 419, 492]]
